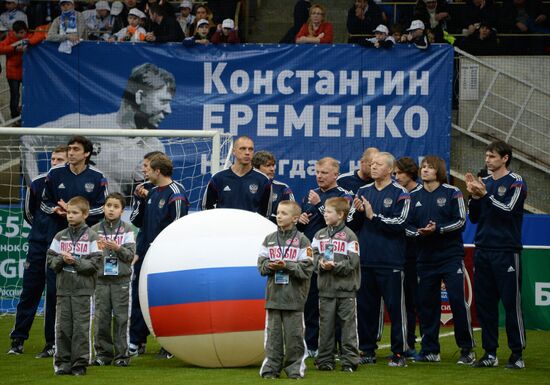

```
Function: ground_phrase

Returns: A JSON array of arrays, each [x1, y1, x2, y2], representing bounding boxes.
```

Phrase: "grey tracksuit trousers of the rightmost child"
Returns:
[[316, 297, 360, 367]]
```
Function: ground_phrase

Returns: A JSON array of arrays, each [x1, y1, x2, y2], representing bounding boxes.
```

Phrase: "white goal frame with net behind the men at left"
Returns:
[[0, 128, 233, 314]]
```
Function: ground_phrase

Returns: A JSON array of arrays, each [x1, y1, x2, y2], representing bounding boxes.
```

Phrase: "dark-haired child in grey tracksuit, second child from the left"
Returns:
[[92, 193, 136, 366]]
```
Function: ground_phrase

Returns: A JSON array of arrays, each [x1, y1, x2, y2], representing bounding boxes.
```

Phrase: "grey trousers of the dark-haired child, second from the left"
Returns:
[[94, 281, 130, 364]]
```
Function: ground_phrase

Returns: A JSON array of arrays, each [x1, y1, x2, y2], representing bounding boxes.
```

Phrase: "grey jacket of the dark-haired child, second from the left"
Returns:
[[92, 220, 136, 283]]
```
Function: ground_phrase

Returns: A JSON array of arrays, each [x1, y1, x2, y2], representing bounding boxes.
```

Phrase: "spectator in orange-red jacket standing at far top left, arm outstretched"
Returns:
[[0, 20, 46, 119]]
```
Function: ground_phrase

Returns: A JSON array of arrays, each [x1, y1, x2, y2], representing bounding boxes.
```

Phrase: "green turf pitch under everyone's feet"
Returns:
[[0, 316, 550, 385]]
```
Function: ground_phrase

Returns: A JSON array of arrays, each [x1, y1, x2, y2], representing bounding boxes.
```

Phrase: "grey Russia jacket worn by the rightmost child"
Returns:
[[312, 223, 361, 298]]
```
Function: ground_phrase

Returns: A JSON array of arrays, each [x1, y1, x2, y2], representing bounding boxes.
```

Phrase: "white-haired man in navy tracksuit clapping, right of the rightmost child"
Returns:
[[351, 152, 410, 367]]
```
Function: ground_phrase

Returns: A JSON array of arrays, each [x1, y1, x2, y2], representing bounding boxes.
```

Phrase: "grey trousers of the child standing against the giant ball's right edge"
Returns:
[[260, 309, 307, 377]]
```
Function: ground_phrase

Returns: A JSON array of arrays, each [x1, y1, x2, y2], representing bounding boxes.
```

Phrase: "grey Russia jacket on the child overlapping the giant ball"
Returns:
[[258, 227, 313, 311]]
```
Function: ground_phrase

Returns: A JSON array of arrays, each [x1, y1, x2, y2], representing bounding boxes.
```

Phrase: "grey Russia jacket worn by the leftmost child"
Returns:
[[46, 224, 101, 296]]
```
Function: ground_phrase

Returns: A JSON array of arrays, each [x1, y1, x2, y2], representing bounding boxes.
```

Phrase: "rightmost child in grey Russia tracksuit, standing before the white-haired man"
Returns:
[[312, 197, 361, 372]]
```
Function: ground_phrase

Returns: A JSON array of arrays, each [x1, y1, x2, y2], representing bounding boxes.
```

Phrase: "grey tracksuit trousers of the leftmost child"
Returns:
[[54, 295, 92, 371]]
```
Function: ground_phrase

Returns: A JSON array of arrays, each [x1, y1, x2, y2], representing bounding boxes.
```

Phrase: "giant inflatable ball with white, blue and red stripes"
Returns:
[[139, 209, 276, 368]]
